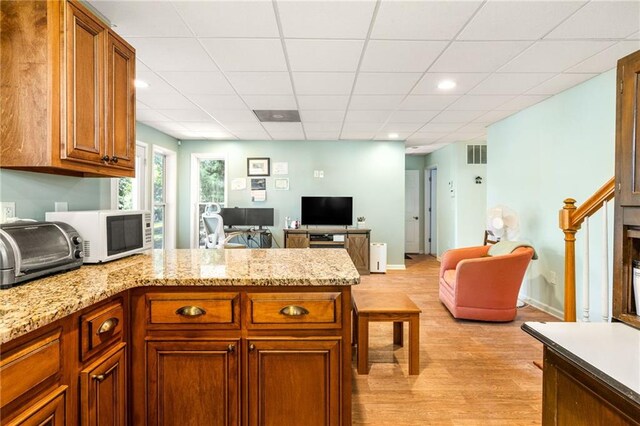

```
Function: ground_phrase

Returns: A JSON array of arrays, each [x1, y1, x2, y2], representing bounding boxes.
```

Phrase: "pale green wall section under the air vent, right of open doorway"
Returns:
[[425, 142, 487, 256]]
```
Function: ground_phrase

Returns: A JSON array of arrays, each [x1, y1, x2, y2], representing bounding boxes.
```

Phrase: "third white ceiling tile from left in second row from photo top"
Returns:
[[285, 39, 364, 72]]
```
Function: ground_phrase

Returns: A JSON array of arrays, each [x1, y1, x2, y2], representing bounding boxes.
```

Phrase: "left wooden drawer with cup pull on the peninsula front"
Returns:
[[148, 293, 240, 328]]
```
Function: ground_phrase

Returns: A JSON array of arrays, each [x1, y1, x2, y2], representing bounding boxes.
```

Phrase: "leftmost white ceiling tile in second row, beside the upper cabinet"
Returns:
[[127, 37, 218, 72]]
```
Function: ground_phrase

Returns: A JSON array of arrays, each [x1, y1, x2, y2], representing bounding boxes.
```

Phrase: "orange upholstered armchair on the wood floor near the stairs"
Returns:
[[439, 246, 535, 321]]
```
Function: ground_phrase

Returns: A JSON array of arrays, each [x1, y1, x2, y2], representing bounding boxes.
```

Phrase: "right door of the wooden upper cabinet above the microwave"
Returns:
[[106, 33, 136, 170]]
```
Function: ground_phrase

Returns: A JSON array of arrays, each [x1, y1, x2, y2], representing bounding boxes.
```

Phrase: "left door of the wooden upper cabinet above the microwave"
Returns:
[[61, 3, 105, 163]]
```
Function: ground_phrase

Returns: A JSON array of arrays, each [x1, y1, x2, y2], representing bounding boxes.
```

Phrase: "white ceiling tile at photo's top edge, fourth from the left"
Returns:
[[371, 0, 482, 40]]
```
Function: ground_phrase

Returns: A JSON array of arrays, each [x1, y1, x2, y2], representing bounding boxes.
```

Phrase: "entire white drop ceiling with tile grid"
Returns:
[[89, 0, 640, 150]]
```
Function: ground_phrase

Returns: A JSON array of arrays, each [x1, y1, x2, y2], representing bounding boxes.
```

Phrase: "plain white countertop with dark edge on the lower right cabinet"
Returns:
[[522, 322, 640, 404]]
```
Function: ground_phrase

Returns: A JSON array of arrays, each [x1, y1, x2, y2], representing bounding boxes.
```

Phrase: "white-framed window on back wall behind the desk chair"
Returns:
[[191, 154, 227, 248]]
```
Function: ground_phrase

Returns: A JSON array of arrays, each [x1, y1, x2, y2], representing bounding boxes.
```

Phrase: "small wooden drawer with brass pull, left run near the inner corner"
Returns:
[[80, 300, 125, 361]]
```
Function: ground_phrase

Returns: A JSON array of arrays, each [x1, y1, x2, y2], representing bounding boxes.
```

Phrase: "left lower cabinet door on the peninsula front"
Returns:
[[147, 340, 240, 426]]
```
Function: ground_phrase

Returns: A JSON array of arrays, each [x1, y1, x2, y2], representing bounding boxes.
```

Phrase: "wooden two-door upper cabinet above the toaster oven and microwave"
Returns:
[[0, 0, 135, 177]]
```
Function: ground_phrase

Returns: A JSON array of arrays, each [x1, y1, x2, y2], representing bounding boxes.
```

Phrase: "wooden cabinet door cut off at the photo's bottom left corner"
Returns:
[[6, 386, 67, 426]]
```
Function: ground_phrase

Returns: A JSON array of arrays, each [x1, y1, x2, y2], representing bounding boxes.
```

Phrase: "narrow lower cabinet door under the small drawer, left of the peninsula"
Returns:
[[80, 343, 127, 426]]
